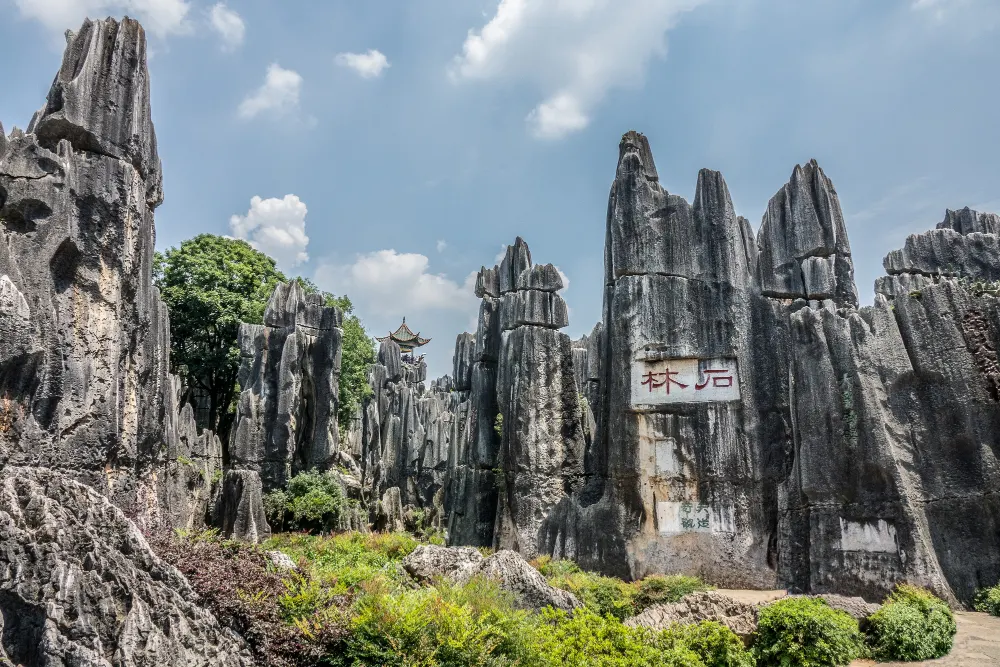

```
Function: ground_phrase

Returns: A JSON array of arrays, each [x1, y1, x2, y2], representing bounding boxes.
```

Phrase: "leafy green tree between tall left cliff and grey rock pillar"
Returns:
[[153, 234, 287, 443]]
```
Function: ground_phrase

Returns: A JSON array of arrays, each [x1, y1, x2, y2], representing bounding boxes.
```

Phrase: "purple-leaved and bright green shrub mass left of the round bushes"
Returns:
[[153, 532, 751, 667]]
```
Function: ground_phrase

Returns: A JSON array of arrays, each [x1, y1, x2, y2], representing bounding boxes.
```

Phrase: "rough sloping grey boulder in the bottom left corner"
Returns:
[[0, 466, 253, 667]]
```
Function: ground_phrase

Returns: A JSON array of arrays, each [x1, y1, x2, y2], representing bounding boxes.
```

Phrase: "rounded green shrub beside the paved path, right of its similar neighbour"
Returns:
[[867, 584, 957, 661]]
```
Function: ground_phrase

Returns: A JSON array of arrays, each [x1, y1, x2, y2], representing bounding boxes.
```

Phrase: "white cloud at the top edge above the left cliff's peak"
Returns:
[[15, 0, 191, 37]]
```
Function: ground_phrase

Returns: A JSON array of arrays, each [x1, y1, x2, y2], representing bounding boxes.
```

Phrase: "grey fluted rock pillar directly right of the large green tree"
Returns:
[[229, 281, 344, 491]]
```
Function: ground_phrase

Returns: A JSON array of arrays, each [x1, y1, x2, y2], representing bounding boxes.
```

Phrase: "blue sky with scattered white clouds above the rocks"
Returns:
[[0, 0, 1000, 375]]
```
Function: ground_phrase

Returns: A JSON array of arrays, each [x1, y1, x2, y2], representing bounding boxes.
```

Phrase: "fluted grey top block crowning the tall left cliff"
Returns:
[[28, 18, 163, 207]]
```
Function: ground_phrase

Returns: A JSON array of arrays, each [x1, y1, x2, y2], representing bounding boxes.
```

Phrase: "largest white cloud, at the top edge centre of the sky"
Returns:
[[450, 0, 707, 139]]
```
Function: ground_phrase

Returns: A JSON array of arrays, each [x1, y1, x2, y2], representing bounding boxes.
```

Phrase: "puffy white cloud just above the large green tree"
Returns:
[[229, 195, 309, 270]]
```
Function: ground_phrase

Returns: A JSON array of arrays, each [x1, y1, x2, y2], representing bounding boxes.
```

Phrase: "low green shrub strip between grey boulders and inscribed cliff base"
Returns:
[[532, 556, 710, 620]]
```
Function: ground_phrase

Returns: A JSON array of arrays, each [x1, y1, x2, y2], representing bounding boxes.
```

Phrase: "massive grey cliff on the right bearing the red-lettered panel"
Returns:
[[516, 132, 1000, 600]]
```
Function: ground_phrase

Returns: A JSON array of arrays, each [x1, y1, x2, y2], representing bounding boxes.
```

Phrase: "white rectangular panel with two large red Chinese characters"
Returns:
[[632, 359, 740, 405]]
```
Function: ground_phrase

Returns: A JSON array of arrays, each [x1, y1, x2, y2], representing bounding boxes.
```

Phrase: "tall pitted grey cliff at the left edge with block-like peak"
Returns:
[[0, 19, 221, 526]]
